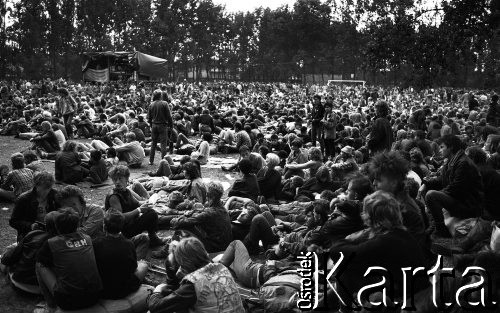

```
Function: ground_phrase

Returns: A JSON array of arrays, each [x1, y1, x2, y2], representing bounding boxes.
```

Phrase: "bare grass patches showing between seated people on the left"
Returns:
[[0, 137, 235, 313]]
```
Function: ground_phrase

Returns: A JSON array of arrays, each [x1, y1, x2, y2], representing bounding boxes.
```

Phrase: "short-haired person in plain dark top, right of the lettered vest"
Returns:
[[93, 209, 148, 299]]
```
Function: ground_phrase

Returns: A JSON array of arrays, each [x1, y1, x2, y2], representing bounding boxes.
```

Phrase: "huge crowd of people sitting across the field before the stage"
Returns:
[[0, 79, 500, 313]]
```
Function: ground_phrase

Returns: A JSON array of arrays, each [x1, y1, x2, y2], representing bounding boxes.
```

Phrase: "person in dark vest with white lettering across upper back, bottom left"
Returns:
[[36, 208, 102, 313]]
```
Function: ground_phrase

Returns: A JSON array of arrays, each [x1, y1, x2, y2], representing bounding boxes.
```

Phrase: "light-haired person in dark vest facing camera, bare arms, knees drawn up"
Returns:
[[104, 165, 164, 247]]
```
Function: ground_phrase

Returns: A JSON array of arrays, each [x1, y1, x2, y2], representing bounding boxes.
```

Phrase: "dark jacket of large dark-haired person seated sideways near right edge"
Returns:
[[426, 150, 483, 216]]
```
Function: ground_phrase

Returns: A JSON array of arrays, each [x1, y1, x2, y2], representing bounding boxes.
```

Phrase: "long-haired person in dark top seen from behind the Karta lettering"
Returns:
[[330, 191, 429, 305]]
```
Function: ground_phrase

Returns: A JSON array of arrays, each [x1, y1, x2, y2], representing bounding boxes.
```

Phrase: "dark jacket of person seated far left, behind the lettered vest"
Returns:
[[9, 188, 59, 237]]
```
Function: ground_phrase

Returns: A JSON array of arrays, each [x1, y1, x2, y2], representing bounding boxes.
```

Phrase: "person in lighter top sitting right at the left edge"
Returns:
[[0, 153, 33, 201]]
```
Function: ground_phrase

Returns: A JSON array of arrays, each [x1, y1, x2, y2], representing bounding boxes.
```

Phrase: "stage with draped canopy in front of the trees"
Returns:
[[82, 51, 168, 82]]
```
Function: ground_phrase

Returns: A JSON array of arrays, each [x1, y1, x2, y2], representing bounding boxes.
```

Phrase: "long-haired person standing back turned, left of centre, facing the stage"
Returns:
[[148, 90, 173, 165]]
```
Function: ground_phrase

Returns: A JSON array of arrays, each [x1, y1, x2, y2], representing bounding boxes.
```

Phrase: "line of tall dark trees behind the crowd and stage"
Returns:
[[0, 0, 500, 87]]
